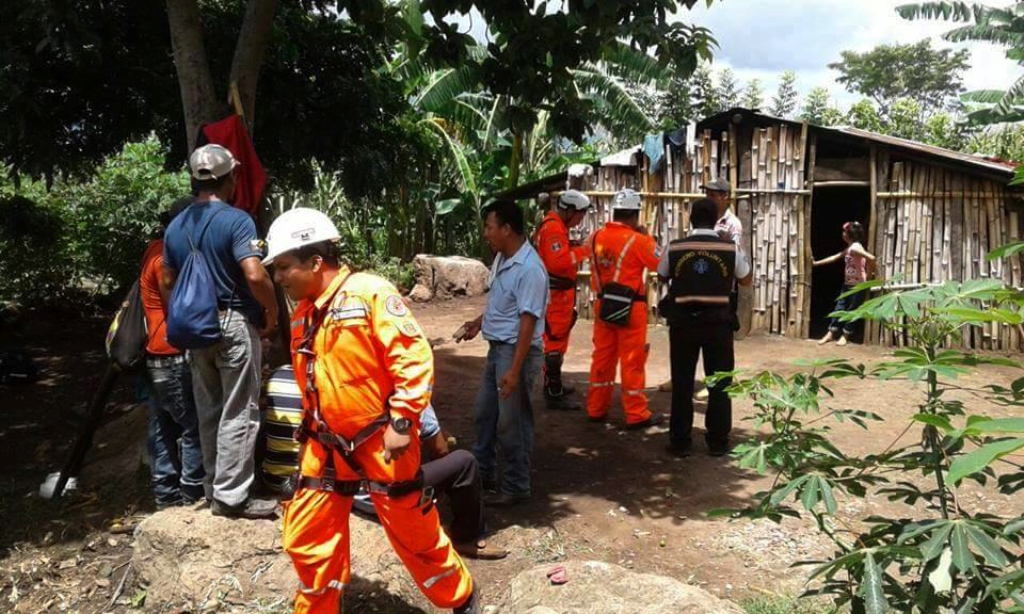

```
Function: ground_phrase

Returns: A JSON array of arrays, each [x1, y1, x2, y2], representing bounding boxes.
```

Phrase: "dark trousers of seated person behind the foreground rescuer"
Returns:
[[420, 450, 483, 543]]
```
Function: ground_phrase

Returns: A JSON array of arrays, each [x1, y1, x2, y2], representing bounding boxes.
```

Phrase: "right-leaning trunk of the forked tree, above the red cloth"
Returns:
[[228, 0, 278, 130]]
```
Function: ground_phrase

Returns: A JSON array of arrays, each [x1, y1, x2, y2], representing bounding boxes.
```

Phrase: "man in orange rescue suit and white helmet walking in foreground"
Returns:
[[264, 209, 477, 614]]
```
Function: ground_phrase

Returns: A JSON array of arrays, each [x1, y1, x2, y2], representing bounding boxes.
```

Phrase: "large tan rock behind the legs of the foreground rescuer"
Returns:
[[132, 508, 427, 612]]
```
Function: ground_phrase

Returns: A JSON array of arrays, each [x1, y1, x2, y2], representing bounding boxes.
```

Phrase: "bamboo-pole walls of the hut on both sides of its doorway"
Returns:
[[573, 124, 1024, 350]]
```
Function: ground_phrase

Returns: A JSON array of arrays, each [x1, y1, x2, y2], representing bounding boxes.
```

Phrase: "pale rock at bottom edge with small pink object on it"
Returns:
[[499, 561, 743, 614]]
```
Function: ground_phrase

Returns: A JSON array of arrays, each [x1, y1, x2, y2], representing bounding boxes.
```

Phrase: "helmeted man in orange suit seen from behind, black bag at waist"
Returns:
[[587, 189, 665, 429]]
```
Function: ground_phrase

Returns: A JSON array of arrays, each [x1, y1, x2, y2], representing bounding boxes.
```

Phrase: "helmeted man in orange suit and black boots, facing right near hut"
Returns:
[[534, 189, 590, 409]]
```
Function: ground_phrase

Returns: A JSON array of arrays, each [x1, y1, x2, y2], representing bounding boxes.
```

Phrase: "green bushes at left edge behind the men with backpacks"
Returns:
[[0, 136, 189, 305]]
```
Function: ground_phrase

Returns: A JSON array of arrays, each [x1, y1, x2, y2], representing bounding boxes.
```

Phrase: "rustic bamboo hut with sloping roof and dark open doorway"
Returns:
[[509, 108, 1024, 350]]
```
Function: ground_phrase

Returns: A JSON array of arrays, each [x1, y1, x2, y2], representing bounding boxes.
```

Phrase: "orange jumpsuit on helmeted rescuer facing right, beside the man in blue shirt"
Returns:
[[534, 211, 590, 354]]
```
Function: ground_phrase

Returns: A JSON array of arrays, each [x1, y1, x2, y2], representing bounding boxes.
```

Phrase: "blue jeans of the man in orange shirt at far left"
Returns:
[[145, 355, 206, 506]]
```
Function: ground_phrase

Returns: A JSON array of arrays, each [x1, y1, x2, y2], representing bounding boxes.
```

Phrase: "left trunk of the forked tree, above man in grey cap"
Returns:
[[167, 0, 223, 151]]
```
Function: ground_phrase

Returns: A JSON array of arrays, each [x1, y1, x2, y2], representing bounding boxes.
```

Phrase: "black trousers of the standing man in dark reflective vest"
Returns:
[[669, 322, 735, 445]]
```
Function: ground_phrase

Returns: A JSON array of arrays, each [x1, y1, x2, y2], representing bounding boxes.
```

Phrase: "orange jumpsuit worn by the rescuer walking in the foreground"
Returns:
[[283, 268, 473, 614]]
